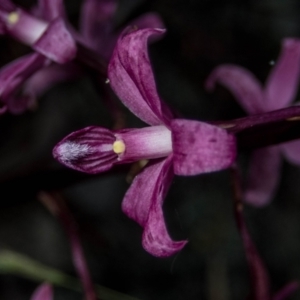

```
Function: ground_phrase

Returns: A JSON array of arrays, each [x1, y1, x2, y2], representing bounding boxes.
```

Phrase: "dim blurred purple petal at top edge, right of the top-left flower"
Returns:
[[80, 0, 117, 54]]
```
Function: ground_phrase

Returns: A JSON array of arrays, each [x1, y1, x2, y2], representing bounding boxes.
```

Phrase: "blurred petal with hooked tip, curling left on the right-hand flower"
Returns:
[[205, 64, 266, 114]]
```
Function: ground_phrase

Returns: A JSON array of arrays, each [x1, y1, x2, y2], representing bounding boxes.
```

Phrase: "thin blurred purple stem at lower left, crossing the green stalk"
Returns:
[[38, 192, 97, 300]]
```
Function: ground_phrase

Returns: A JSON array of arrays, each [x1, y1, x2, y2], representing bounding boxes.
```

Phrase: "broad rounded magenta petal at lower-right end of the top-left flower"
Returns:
[[33, 19, 76, 64]]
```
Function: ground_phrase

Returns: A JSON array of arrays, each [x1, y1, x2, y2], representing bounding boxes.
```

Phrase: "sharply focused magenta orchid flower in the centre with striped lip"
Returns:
[[53, 28, 236, 257]]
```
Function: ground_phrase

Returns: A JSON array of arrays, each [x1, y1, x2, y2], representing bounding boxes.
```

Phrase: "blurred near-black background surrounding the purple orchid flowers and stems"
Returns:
[[0, 0, 300, 300]]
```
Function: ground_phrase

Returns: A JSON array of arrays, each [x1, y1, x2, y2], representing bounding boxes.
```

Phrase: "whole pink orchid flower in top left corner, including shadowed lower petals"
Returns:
[[0, 0, 76, 114]]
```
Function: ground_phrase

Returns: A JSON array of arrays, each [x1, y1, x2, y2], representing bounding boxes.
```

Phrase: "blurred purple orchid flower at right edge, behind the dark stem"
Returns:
[[206, 38, 300, 206]]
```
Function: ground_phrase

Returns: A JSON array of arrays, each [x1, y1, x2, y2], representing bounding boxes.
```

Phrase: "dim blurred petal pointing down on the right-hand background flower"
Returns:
[[244, 146, 282, 206]]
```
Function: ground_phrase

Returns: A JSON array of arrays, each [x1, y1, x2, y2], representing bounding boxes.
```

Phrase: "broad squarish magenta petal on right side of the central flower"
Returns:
[[171, 119, 236, 175]]
